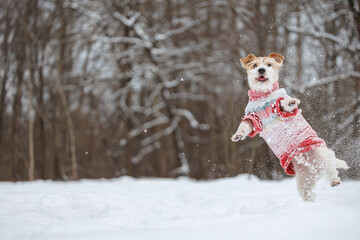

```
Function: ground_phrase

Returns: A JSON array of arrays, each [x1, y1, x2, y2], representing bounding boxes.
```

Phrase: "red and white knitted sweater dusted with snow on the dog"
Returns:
[[242, 82, 326, 175]]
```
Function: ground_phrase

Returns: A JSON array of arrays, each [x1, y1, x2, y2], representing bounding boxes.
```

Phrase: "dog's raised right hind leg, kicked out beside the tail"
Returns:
[[314, 147, 340, 187]]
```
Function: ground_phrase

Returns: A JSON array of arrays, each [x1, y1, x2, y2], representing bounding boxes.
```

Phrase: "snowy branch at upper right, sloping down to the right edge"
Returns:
[[286, 26, 360, 52]]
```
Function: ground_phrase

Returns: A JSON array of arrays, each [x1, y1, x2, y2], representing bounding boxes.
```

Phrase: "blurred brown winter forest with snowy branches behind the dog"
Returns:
[[0, 0, 360, 181]]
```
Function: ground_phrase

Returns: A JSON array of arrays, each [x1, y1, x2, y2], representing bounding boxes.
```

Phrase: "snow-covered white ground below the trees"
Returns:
[[0, 175, 360, 240]]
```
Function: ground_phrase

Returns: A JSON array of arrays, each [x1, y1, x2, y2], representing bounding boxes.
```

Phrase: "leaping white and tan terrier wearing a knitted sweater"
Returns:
[[231, 53, 349, 201]]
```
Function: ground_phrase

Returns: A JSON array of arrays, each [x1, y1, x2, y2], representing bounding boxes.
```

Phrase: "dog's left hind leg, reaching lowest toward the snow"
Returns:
[[293, 154, 317, 202]]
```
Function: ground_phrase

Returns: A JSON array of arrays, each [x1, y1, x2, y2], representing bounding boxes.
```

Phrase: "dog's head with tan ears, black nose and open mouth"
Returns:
[[240, 53, 285, 91]]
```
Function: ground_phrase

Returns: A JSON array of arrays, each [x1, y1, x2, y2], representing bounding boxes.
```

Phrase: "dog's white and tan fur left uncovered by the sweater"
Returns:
[[231, 53, 349, 201]]
